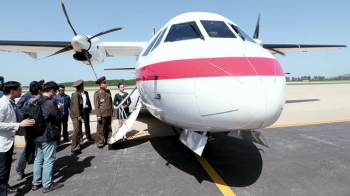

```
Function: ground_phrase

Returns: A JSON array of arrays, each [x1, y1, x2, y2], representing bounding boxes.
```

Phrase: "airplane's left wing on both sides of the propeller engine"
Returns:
[[0, 40, 147, 59]]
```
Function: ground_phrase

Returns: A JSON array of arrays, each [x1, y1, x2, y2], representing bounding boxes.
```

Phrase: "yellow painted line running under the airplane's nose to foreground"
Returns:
[[174, 127, 236, 196]]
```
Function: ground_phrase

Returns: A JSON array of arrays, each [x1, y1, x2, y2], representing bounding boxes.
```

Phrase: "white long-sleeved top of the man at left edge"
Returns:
[[0, 95, 19, 152]]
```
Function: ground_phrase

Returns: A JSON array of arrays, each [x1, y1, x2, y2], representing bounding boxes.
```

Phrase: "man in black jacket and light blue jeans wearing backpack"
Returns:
[[32, 82, 63, 193]]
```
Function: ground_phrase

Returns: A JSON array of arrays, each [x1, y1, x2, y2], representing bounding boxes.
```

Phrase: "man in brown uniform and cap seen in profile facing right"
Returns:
[[70, 80, 84, 154]]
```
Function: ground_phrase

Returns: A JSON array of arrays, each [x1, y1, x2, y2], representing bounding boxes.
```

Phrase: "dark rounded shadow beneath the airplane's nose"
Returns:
[[150, 134, 263, 187]]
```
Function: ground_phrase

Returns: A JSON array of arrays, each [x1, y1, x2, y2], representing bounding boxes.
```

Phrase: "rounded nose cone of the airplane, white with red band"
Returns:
[[195, 58, 266, 128]]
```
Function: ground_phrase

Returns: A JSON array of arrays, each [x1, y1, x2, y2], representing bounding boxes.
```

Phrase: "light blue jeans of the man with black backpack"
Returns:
[[33, 141, 57, 188]]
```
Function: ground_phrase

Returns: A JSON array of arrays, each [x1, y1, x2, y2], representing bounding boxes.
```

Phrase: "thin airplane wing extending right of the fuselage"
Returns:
[[262, 44, 346, 55]]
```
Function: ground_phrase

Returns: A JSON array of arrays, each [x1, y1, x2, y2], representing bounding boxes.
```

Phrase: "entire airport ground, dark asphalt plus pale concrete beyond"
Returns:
[[9, 83, 350, 196]]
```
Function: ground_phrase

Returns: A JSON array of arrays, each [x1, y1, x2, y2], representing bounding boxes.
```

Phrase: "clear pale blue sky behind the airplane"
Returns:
[[0, 0, 350, 85]]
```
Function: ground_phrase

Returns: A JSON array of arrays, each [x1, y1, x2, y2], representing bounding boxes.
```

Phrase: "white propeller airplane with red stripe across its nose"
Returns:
[[0, 2, 346, 155]]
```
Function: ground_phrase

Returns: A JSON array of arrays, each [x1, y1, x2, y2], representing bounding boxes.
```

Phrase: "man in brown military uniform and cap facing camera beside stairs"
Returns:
[[94, 76, 114, 148]]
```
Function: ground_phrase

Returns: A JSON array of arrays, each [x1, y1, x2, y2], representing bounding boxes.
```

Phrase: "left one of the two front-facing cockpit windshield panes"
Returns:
[[164, 21, 204, 42]]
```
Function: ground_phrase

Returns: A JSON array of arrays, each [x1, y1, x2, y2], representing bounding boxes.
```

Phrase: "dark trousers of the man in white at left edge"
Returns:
[[0, 145, 13, 196]]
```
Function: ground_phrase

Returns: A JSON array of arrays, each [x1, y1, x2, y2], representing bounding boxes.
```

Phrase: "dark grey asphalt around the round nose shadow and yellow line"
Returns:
[[10, 122, 350, 196]]
